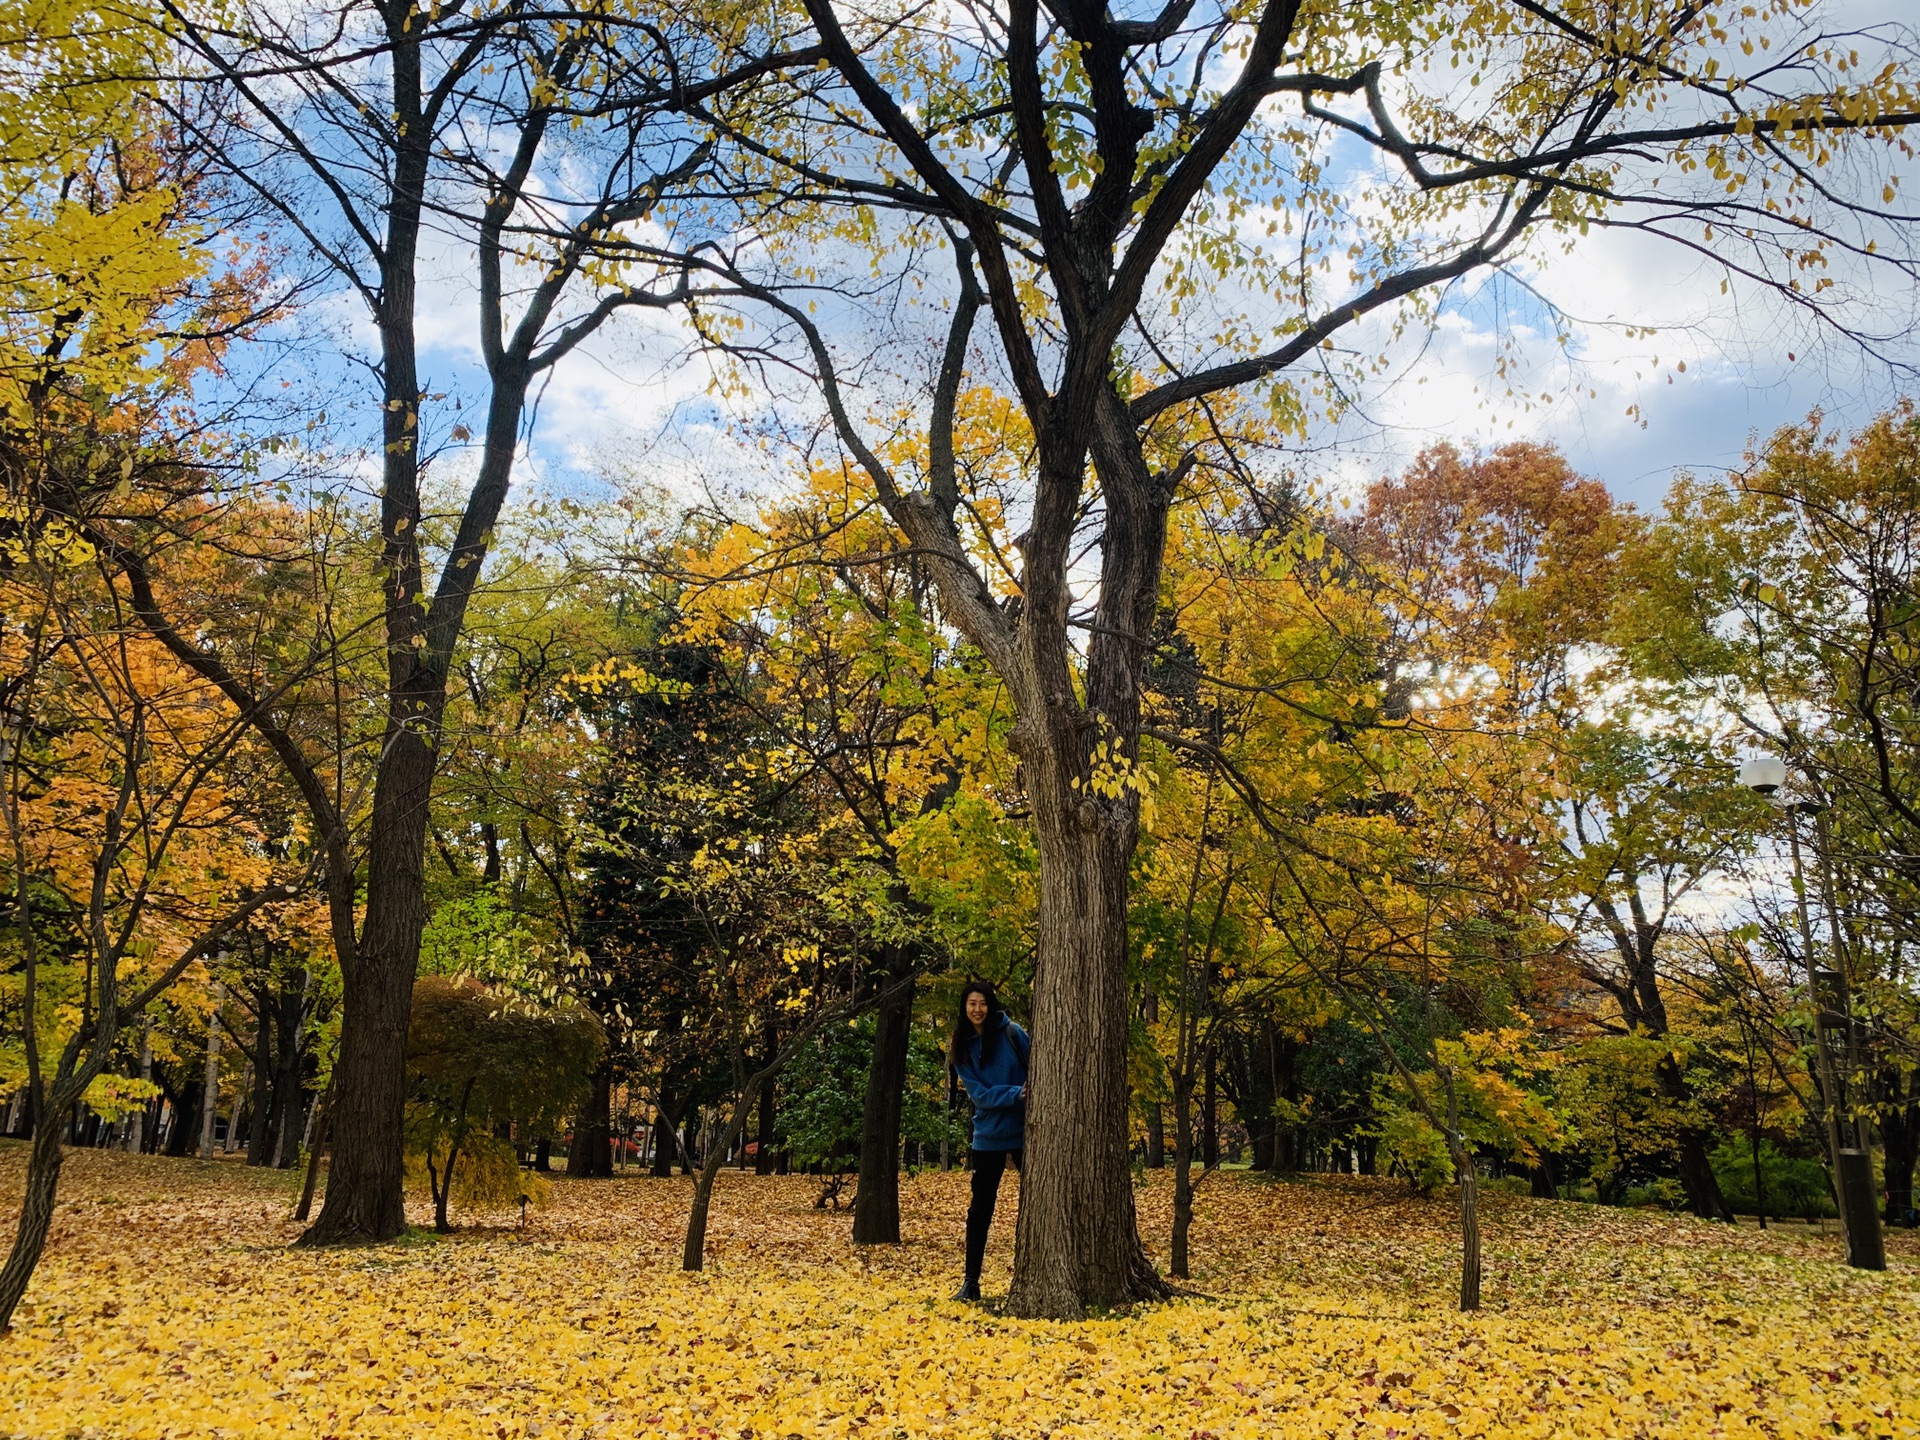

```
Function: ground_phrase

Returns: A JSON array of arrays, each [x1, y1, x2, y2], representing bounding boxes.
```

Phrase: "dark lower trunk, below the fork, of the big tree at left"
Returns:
[[300, 725, 434, 1246]]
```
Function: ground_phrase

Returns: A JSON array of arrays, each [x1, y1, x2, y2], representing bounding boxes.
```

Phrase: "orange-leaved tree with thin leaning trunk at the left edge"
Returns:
[[0, 516, 311, 1327]]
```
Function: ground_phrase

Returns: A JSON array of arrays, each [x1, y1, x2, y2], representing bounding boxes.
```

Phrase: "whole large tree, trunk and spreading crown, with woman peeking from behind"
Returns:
[[683, 0, 1914, 1317]]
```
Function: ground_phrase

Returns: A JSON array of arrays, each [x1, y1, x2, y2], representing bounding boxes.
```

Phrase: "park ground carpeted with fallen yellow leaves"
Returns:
[[0, 1142, 1920, 1440]]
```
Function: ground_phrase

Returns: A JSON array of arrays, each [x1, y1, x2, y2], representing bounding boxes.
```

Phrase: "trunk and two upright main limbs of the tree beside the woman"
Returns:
[[1006, 414, 1171, 1319]]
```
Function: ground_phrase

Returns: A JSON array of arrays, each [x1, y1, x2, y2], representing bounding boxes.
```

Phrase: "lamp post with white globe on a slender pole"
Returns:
[[1740, 755, 1887, 1269]]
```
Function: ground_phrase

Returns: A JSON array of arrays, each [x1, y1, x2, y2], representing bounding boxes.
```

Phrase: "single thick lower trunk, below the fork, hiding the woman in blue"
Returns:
[[1006, 748, 1165, 1319]]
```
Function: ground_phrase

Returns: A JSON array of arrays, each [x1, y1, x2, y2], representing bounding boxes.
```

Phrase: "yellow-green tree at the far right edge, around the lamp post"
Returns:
[[1620, 403, 1920, 1219]]
